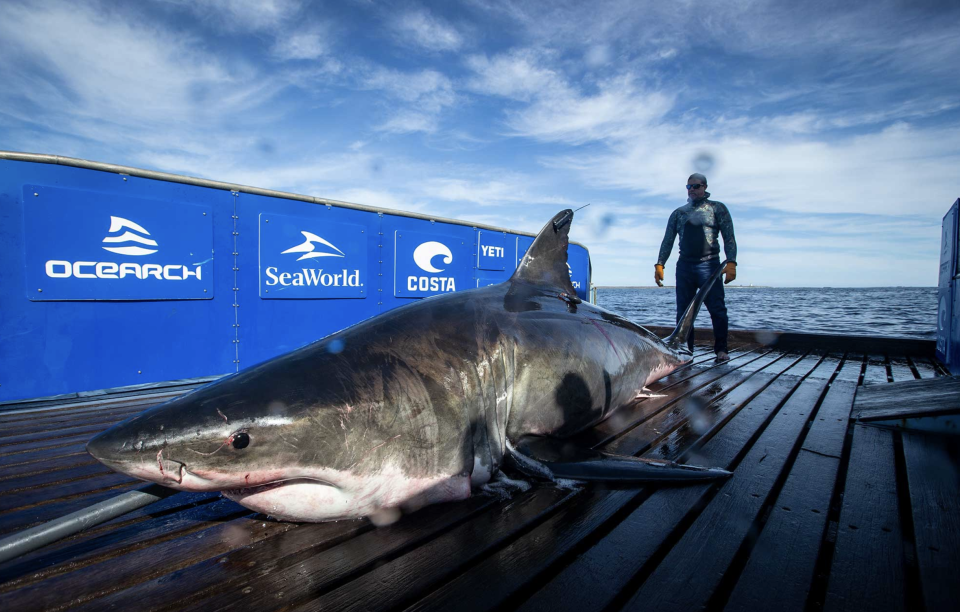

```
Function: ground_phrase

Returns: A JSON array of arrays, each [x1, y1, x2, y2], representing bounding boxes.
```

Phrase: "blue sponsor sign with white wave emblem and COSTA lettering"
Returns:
[[394, 230, 474, 298]]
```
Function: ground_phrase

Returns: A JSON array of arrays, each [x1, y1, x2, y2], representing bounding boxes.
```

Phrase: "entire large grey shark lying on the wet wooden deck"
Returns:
[[87, 210, 729, 521]]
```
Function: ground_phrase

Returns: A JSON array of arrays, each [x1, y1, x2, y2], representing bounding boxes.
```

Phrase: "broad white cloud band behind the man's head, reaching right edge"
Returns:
[[544, 119, 960, 219]]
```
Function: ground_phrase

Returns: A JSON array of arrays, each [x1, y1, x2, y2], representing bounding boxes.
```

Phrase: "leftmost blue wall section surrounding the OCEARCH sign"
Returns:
[[0, 160, 235, 401]]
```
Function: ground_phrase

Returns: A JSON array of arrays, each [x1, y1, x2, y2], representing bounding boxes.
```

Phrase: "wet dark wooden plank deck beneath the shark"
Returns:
[[0, 343, 960, 612]]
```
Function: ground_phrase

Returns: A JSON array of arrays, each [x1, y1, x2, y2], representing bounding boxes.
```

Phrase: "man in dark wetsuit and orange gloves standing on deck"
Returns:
[[653, 173, 737, 361]]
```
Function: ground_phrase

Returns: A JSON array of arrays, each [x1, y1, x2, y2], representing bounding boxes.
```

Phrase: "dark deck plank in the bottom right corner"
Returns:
[[903, 432, 960, 610]]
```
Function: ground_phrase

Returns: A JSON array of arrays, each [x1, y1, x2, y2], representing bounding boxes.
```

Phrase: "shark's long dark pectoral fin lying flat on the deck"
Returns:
[[511, 436, 732, 484]]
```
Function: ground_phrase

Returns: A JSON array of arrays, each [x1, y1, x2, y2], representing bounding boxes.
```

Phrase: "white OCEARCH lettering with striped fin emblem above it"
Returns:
[[44, 216, 202, 280]]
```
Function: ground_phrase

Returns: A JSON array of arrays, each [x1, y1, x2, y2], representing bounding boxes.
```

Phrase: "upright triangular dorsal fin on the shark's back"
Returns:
[[510, 209, 577, 295]]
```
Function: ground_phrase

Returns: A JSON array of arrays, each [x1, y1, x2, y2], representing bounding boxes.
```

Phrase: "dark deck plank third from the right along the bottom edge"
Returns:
[[724, 381, 856, 611]]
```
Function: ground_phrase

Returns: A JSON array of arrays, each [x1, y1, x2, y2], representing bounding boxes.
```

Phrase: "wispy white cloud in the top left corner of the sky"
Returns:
[[0, 3, 282, 128]]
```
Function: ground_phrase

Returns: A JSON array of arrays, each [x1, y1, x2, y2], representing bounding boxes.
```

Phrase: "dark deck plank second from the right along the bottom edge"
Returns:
[[824, 425, 907, 612]]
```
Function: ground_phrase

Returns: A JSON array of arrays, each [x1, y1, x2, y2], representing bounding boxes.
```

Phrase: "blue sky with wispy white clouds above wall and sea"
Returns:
[[0, 0, 960, 287]]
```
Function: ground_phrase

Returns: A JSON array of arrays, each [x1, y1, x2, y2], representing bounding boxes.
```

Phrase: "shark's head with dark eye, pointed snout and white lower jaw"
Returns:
[[87, 346, 469, 521]]
